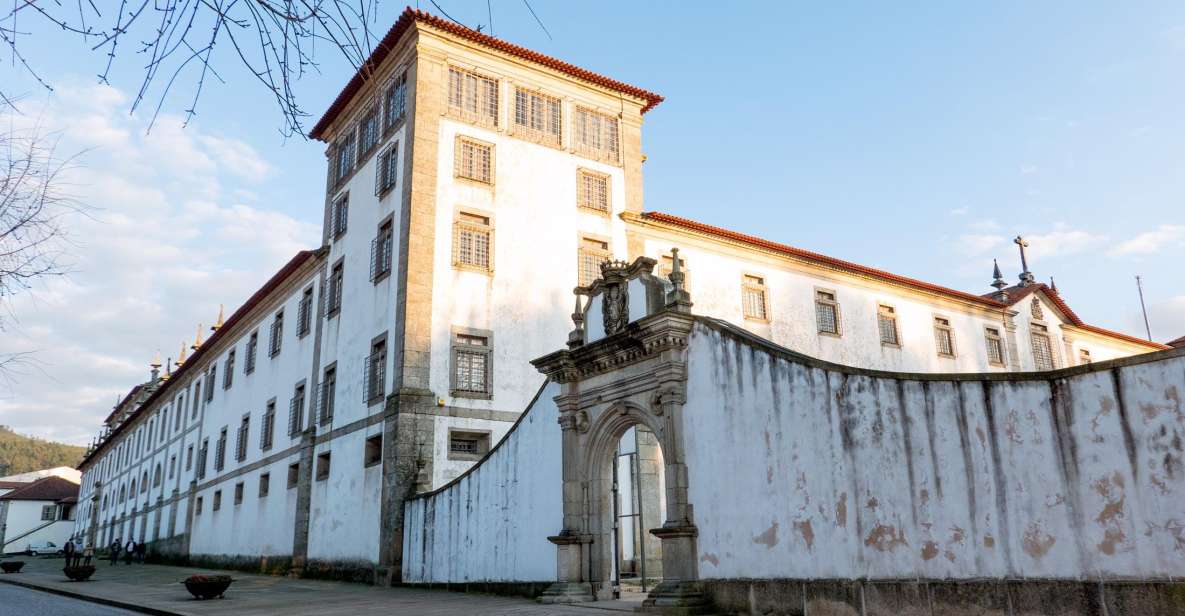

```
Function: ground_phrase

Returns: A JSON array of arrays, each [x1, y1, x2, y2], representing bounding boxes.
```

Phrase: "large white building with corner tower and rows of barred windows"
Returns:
[[77, 9, 1164, 580]]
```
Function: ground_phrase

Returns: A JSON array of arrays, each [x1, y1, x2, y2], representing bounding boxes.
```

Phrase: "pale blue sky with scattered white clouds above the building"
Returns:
[[0, 0, 1185, 443]]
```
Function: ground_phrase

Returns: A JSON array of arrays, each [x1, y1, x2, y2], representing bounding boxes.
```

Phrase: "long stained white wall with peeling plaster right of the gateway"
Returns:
[[685, 322, 1185, 579]]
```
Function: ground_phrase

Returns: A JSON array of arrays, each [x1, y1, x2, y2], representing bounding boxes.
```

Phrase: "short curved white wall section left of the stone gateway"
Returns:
[[403, 384, 563, 583]]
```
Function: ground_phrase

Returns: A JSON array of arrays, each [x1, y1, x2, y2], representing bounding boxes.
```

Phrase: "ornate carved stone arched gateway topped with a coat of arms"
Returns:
[[534, 255, 705, 612]]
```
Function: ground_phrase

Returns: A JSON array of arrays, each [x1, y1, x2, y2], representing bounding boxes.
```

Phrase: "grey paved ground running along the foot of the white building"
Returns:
[[0, 558, 636, 616]]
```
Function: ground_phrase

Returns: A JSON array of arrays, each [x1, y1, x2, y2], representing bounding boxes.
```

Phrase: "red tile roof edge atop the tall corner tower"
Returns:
[[308, 6, 662, 139]]
